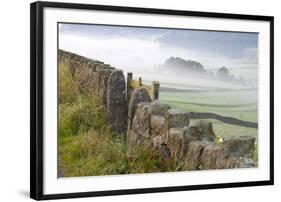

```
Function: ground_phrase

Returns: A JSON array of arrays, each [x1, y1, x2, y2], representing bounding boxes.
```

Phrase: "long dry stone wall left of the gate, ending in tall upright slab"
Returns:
[[58, 50, 127, 133]]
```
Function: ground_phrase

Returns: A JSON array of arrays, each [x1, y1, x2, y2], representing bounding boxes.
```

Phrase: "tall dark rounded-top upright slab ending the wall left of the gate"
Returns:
[[106, 70, 127, 133]]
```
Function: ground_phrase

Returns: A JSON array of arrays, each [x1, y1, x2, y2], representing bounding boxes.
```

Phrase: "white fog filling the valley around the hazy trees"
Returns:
[[59, 24, 258, 90]]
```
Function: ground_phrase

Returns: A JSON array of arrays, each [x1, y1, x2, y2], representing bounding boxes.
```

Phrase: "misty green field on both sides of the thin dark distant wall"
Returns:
[[160, 90, 258, 141]]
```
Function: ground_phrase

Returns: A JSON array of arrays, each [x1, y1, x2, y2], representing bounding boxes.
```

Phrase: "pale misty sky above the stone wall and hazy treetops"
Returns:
[[59, 23, 258, 88]]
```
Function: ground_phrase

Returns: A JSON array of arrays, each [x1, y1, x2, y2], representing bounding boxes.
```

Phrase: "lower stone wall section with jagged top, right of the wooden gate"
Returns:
[[127, 89, 255, 170]]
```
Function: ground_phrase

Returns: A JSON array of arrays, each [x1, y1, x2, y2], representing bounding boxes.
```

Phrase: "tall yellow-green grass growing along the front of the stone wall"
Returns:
[[58, 63, 181, 177]]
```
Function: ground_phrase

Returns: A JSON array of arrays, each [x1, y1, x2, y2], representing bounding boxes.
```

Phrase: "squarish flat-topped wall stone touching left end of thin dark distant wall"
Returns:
[[165, 109, 189, 130]]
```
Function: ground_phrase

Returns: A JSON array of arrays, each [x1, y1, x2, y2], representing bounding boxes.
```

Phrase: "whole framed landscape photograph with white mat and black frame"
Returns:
[[30, 2, 274, 200]]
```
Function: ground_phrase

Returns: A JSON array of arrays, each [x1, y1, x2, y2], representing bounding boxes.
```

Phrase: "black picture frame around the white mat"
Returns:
[[30, 2, 274, 200]]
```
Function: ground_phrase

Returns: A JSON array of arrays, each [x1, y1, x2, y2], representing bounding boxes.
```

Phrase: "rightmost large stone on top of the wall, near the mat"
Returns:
[[223, 135, 255, 158]]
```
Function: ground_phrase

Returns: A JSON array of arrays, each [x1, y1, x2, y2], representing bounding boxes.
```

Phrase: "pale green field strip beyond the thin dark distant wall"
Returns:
[[160, 91, 258, 122]]
